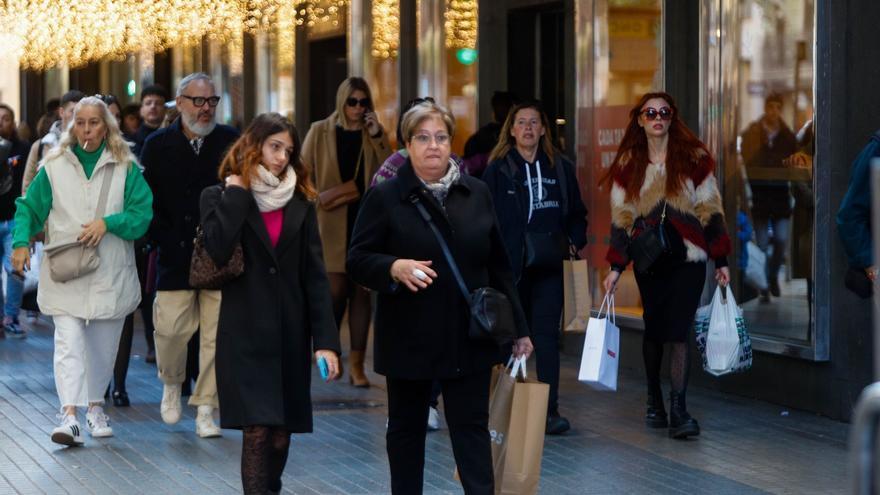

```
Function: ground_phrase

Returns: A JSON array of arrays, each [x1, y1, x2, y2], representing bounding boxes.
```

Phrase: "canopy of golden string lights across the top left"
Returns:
[[0, 0, 348, 70]]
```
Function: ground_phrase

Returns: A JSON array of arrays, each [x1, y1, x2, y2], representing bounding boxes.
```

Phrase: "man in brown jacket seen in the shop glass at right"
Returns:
[[741, 93, 797, 303]]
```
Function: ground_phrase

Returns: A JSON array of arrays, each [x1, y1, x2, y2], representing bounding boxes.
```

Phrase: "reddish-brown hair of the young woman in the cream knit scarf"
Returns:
[[219, 112, 318, 199]]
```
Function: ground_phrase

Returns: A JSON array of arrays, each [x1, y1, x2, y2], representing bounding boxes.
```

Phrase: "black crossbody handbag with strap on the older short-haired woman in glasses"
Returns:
[[410, 194, 516, 345]]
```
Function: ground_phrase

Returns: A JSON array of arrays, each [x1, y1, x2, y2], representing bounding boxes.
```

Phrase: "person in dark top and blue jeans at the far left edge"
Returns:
[[0, 103, 30, 338]]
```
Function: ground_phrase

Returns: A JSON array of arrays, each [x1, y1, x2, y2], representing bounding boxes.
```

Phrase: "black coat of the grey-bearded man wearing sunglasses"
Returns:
[[140, 118, 238, 290]]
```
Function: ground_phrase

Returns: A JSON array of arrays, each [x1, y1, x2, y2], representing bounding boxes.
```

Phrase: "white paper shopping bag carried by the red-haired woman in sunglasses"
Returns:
[[578, 294, 620, 390]]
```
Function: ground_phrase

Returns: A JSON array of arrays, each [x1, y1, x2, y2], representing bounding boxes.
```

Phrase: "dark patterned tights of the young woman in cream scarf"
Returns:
[[241, 425, 290, 495]]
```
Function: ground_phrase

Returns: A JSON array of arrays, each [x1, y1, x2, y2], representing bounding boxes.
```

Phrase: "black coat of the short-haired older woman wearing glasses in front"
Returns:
[[346, 160, 529, 379]]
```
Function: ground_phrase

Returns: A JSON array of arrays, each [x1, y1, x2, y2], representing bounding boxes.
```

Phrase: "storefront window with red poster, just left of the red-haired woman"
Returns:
[[576, 0, 663, 317]]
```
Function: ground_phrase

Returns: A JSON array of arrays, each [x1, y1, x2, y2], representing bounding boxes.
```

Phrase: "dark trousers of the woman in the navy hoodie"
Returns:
[[516, 263, 565, 415]]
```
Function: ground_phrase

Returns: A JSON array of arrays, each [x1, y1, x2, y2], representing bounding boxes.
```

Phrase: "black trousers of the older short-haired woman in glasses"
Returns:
[[385, 370, 495, 495]]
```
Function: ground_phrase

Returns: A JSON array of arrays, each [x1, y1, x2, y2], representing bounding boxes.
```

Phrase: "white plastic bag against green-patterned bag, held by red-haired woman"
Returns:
[[706, 286, 740, 373]]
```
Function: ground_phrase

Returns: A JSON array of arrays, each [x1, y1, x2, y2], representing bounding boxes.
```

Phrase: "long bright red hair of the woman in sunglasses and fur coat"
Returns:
[[599, 92, 709, 199]]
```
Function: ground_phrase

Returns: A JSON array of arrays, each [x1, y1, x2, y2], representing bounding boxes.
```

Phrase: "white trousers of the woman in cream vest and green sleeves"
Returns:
[[52, 316, 125, 408]]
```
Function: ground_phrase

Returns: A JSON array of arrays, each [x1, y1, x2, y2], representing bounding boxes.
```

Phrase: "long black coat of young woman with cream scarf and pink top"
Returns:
[[201, 186, 340, 433]]
